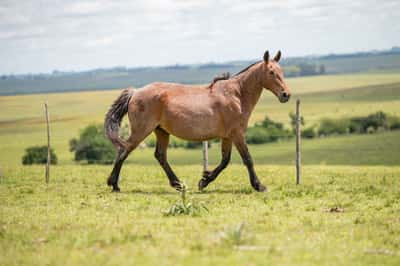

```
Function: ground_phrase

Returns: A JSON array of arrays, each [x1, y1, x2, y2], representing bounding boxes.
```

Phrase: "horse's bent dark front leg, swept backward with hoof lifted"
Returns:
[[199, 139, 232, 191]]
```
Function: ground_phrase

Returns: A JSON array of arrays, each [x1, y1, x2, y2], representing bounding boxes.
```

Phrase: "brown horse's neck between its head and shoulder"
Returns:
[[237, 65, 263, 116]]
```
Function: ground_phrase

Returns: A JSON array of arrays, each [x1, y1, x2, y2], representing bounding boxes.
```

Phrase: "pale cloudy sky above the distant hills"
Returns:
[[0, 0, 400, 74]]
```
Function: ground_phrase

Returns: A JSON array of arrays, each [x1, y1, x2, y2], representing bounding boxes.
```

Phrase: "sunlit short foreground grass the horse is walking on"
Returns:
[[0, 165, 400, 265]]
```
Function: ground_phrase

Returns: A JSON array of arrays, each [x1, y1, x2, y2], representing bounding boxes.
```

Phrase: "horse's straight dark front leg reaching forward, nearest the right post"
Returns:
[[233, 134, 267, 192]]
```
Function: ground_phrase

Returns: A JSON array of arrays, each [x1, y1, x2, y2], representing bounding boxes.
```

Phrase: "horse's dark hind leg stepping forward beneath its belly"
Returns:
[[154, 127, 182, 190]]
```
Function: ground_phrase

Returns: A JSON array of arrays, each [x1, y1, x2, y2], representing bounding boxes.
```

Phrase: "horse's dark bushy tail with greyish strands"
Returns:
[[104, 89, 133, 149]]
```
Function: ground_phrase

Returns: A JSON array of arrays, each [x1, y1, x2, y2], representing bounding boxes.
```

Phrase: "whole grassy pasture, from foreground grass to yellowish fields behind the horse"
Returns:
[[0, 72, 400, 265]]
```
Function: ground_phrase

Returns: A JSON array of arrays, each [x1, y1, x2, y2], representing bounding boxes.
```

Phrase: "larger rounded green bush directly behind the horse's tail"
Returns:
[[69, 125, 115, 164]]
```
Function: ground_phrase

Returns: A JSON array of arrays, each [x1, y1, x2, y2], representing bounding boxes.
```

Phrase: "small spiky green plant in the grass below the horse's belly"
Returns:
[[164, 182, 208, 216]]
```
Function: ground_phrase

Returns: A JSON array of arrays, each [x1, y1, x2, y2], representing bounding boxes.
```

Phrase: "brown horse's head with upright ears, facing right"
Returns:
[[261, 51, 291, 103]]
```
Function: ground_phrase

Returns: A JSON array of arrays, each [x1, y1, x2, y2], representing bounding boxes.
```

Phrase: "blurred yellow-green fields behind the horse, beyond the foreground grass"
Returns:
[[0, 71, 400, 165]]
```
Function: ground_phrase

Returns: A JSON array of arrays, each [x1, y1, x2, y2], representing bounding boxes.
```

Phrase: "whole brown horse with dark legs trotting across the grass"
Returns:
[[104, 51, 290, 191]]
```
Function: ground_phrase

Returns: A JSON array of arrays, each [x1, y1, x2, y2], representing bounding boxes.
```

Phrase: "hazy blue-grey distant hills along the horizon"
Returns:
[[0, 47, 400, 95]]
